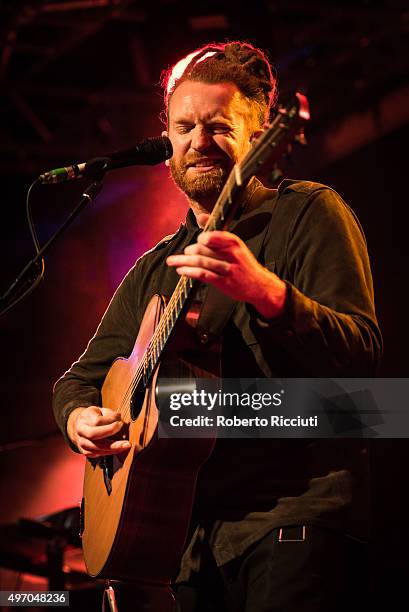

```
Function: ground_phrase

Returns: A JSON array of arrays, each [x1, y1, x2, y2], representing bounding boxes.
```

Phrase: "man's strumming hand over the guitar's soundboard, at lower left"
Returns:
[[67, 406, 131, 458]]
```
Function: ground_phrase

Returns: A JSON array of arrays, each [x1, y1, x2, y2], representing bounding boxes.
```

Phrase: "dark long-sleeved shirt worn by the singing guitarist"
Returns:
[[54, 181, 382, 580]]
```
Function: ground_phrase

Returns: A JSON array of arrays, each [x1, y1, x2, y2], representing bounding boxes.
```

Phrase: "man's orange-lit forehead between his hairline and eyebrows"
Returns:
[[169, 81, 244, 121]]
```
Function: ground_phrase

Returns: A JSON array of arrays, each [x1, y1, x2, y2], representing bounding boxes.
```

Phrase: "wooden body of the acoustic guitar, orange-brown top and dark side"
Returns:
[[82, 296, 214, 587]]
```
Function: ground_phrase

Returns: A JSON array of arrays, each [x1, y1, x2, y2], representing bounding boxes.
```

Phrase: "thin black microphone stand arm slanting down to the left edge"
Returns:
[[0, 173, 106, 315]]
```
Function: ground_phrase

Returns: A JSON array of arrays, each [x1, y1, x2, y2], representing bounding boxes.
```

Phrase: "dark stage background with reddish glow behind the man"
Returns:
[[0, 0, 409, 604]]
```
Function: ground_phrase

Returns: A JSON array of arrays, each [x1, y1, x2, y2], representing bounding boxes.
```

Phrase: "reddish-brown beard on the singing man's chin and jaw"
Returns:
[[170, 159, 228, 202]]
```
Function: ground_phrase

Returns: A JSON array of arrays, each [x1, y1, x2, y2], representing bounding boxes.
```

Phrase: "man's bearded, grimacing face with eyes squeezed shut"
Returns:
[[164, 81, 252, 207]]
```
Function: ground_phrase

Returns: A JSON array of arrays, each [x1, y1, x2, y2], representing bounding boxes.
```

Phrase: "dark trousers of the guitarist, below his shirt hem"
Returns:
[[175, 526, 368, 612]]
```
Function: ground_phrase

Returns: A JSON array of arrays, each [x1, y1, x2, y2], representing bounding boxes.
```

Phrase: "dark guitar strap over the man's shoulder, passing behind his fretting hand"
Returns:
[[196, 179, 277, 344]]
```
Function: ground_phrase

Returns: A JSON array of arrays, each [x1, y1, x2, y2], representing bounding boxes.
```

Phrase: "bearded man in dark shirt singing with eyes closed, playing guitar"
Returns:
[[54, 43, 381, 612]]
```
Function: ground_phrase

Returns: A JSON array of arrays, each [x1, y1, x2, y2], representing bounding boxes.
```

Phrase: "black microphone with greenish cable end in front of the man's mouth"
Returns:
[[38, 136, 173, 184]]
